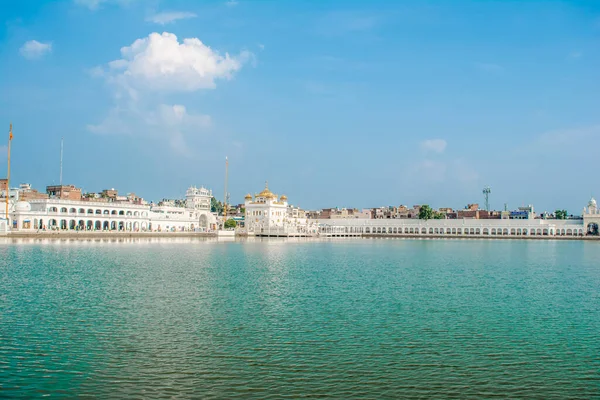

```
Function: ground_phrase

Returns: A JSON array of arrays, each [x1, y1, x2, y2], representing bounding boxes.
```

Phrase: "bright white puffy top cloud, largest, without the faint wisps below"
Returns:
[[102, 32, 253, 96]]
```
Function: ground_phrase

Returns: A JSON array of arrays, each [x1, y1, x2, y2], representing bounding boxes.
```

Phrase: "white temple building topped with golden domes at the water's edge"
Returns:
[[244, 183, 317, 236]]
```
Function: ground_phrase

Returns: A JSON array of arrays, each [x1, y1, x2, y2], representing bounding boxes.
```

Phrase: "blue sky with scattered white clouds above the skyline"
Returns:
[[0, 0, 600, 213]]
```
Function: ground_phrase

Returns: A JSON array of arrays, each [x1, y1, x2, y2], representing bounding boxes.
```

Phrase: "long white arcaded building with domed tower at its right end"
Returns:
[[9, 188, 216, 232]]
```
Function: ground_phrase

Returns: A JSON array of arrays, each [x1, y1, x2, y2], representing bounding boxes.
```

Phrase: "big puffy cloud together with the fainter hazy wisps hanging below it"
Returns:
[[87, 32, 251, 156]]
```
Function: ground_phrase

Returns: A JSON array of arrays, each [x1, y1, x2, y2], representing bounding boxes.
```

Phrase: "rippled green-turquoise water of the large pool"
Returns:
[[0, 239, 600, 399]]
